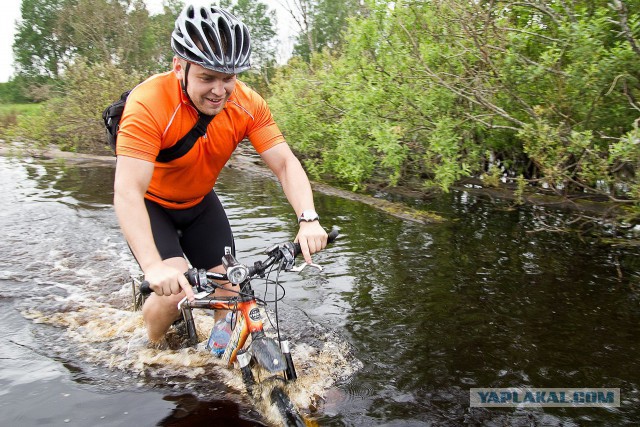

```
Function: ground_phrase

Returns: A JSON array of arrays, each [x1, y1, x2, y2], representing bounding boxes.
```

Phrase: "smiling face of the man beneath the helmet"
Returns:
[[173, 58, 236, 116]]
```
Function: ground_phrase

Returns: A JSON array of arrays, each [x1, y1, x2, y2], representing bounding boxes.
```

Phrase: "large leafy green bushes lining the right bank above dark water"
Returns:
[[270, 0, 640, 211]]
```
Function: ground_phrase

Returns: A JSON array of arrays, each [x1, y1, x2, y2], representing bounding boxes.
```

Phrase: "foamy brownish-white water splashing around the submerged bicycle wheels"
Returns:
[[22, 283, 360, 425]]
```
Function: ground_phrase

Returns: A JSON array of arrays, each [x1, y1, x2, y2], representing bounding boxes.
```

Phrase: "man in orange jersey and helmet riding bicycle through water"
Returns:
[[114, 5, 327, 342]]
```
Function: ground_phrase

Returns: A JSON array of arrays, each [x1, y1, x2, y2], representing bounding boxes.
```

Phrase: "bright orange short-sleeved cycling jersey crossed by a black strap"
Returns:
[[116, 71, 284, 209]]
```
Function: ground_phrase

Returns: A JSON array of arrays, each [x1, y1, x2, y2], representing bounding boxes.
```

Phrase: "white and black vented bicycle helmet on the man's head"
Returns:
[[171, 5, 251, 74]]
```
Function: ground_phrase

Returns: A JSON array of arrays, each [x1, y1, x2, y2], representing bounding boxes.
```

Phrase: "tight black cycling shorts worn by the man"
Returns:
[[145, 191, 235, 270]]
